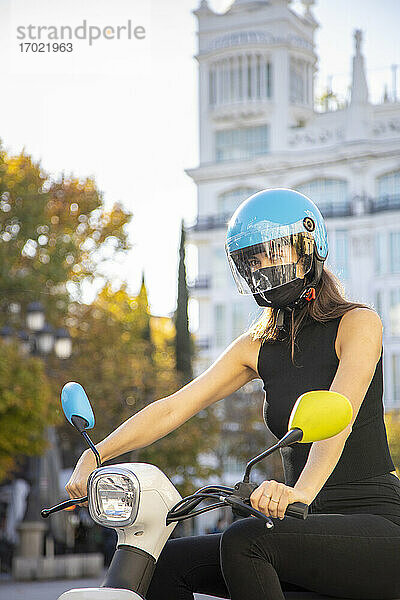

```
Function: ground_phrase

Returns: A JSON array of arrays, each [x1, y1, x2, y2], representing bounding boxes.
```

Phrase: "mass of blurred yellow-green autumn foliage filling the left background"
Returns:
[[0, 147, 219, 491]]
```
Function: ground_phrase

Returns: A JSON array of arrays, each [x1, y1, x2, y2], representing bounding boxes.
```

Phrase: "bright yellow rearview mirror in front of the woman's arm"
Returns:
[[288, 390, 353, 444]]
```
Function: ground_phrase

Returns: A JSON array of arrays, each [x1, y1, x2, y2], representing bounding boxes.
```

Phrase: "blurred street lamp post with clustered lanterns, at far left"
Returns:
[[10, 302, 72, 558]]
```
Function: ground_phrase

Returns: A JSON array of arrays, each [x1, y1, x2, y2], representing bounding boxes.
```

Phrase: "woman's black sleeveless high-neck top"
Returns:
[[258, 317, 400, 514]]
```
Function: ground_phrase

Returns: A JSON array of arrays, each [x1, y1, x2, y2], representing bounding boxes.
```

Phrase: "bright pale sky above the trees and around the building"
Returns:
[[0, 0, 400, 315]]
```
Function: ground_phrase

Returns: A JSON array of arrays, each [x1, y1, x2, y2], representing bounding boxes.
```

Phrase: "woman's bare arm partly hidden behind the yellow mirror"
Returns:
[[294, 308, 382, 503]]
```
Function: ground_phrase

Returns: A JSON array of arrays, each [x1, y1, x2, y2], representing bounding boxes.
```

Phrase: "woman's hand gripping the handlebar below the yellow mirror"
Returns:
[[250, 479, 310, 519]]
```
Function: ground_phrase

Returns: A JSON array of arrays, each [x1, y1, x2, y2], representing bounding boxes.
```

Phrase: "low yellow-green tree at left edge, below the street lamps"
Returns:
[[0, 343, 52, 481]]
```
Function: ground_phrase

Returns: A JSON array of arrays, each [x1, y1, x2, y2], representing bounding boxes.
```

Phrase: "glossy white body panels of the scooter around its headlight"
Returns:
[[58, 463, 181, 600]]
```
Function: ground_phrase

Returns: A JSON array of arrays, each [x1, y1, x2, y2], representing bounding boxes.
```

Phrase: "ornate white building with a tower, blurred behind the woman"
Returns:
[[187, 0, 400, 479]]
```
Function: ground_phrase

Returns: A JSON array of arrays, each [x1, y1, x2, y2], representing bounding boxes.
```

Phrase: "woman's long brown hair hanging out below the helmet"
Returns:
[[249, 266, 371, 364]]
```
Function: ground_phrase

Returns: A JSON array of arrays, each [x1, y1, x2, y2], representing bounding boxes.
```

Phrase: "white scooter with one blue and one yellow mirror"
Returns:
[[41, 382, 353, 600]]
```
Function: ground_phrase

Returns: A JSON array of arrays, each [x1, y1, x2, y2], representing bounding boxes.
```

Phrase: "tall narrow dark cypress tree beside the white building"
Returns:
[[175, 221, 193, 382]]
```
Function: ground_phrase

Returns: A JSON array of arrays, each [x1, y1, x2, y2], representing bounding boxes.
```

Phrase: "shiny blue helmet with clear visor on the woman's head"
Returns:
[[225, 188, 328, 308]]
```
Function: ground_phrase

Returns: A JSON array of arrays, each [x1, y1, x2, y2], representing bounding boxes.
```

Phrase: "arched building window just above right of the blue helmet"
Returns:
[[296, 179, 350, 217]]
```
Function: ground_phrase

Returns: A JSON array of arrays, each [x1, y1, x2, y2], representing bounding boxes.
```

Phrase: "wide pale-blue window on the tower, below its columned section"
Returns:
[[215, 125, 269, 162]]
